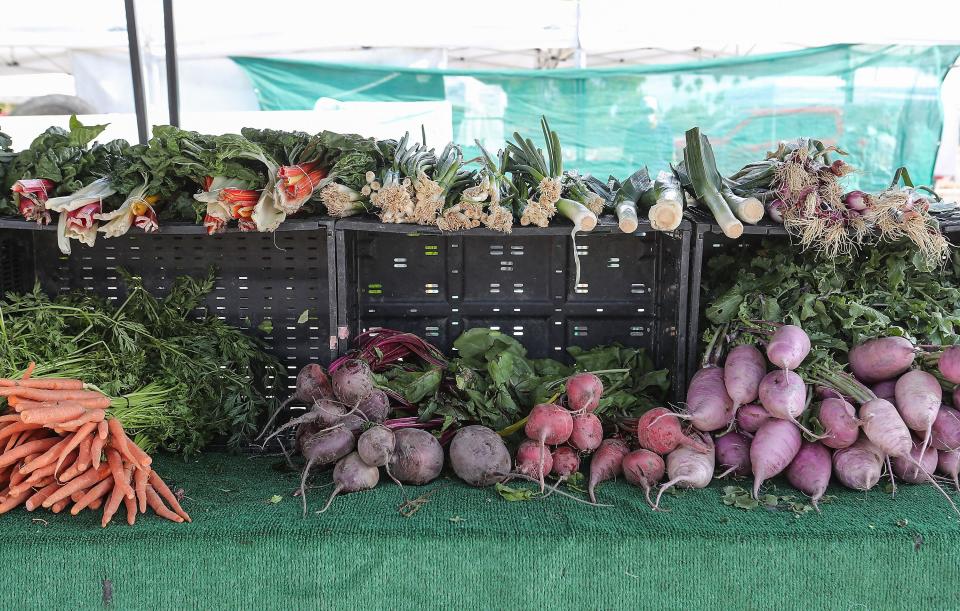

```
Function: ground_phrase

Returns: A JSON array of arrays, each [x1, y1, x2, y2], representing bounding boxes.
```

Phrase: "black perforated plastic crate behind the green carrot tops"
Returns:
[[0, 219, 337, 388]]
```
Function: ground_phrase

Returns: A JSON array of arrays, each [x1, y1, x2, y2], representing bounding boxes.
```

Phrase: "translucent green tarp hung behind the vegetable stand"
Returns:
[[232, 45, 960, 189]]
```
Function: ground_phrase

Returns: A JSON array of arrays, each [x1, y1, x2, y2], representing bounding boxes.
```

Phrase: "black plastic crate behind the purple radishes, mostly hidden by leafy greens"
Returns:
[[686, 208, 960, 379]]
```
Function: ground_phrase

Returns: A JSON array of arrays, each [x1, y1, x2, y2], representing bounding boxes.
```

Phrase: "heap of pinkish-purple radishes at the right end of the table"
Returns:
[[676, 325, 960, 511]]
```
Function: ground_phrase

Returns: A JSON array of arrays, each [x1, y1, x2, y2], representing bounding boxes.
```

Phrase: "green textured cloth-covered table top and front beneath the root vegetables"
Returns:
[[9, 454, 960, 609]]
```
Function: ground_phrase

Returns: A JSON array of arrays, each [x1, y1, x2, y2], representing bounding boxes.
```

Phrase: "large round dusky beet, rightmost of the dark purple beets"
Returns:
[[450, 425, 510, 488]]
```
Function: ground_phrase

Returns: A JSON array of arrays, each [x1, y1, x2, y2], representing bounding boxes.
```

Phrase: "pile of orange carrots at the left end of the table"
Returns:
[[0, 363, 190, 527]]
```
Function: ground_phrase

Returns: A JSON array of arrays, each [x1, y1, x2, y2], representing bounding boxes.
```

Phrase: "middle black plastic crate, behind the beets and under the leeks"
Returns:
[[336, 219, 691, 400]]
